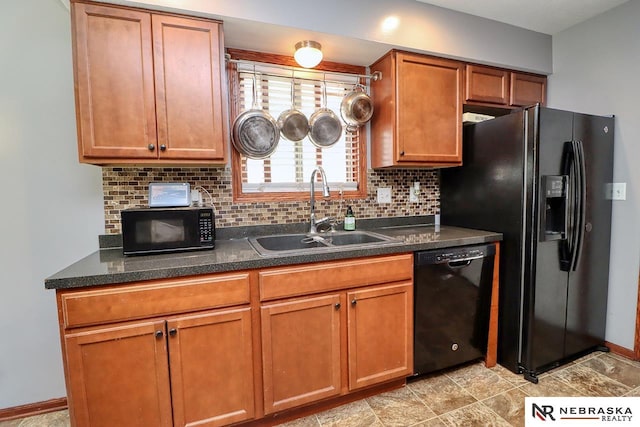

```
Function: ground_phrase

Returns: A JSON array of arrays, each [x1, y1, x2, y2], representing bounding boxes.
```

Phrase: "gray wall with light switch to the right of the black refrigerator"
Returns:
[[548, 0, 640, 349]]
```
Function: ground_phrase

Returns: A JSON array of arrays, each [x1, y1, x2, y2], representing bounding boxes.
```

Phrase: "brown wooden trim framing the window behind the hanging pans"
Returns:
[[226, 48, 368, 202]]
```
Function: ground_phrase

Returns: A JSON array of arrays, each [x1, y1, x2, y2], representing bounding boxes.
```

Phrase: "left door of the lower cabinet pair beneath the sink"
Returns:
[[261, 295, 341, 414]]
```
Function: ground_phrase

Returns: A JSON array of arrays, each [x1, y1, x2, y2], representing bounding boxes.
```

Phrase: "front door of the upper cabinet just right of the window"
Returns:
[[396, 53, 463, 164]]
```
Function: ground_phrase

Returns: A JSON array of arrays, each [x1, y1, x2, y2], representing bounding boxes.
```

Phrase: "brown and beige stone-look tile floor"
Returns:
[[0, 352, 640, 427]]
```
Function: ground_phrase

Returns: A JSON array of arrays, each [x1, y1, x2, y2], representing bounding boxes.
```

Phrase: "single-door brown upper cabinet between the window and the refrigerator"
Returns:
[[371, 50, 464, 168]]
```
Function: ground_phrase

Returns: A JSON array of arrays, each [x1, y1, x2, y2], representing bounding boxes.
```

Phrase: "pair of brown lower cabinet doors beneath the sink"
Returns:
[[262, 283, 413, 414]]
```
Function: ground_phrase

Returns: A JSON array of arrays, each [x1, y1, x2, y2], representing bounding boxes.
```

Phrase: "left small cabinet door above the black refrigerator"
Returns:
[[465, 65, 509, 105]]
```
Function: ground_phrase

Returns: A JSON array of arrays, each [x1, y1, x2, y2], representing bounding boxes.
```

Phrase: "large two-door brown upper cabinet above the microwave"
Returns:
[[72, 3, 228, 164]]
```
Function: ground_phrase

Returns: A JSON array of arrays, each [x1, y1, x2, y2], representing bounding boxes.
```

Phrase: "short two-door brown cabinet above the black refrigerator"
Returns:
[[465, 64, 547, 108]]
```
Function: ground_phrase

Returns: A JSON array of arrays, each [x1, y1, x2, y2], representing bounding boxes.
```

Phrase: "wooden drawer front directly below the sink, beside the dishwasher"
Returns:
[[259, 254, 413, 301]]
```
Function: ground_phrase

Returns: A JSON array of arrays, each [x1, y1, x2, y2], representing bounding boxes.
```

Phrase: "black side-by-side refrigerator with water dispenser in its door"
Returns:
[[440, 105, 614, 382]]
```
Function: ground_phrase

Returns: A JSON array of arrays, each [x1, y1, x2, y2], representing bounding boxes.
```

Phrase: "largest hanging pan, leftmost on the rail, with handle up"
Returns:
[[231, 70, 280, 159]]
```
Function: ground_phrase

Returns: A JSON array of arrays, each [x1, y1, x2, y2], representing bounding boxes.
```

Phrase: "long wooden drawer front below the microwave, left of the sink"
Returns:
[[58, 273, 249, 328]]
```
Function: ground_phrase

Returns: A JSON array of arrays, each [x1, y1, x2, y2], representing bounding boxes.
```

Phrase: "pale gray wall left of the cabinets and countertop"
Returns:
[[0, 0, 104, 408]]
